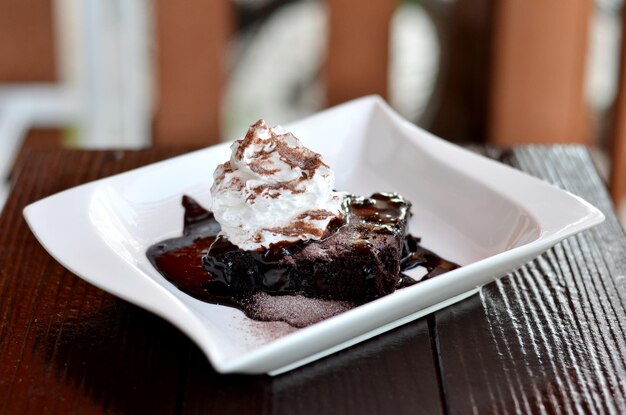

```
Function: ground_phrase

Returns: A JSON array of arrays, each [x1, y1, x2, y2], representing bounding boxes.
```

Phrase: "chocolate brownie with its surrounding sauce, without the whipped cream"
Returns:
[[146, 194, 457, 327]]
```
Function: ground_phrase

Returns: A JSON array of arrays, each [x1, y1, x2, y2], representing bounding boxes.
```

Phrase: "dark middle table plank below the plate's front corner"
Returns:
[[183, 319, 443, 414]]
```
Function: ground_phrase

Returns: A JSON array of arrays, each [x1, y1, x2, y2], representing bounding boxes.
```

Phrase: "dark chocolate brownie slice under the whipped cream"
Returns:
[[202, 193, 410, 303]]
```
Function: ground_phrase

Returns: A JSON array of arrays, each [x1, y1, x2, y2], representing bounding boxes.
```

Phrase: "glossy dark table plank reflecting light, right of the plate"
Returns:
[[434, 147, 626, 414]]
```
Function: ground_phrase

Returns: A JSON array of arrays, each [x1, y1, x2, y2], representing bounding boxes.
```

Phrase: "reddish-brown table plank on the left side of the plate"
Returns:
[[0, 150, 195, 414]]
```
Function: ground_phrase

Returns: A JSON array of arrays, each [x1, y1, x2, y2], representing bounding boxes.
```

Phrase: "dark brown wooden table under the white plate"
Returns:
[[0, 147, 626, 414]]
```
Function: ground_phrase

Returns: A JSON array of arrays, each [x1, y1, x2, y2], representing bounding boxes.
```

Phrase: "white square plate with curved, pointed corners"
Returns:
[[24, 97, 604, 374]]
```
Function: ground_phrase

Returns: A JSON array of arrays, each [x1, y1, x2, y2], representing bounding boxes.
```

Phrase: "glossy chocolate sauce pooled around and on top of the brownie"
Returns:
[[146, 194, 458, 327]]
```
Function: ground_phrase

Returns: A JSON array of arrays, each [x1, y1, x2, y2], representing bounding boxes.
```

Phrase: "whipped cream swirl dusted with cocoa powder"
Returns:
[[211, 120, 345, 251]]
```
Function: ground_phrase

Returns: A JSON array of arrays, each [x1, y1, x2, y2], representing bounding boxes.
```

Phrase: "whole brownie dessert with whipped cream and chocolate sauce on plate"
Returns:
[[147, 120, 456, 326]]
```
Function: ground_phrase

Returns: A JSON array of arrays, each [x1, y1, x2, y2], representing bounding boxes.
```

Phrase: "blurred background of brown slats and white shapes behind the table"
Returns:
[[0, 0, 626, 218]]
